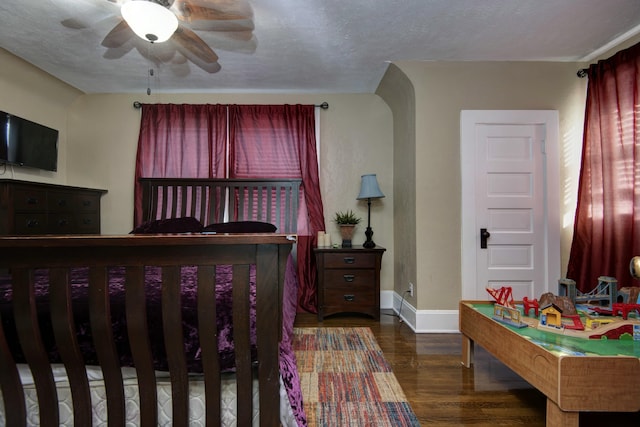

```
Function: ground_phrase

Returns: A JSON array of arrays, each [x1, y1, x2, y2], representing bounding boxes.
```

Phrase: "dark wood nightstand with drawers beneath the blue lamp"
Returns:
[[314, 246, 386, 321]]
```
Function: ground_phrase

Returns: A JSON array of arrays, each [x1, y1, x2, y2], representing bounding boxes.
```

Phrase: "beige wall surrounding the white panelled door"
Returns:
[[378, 62, 586, 310]]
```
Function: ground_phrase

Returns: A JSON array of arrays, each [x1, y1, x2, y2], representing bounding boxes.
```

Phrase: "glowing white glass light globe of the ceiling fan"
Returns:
[[120, 0, 178, 43]]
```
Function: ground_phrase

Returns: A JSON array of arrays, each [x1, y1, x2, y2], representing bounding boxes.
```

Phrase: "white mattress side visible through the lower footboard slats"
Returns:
[[0, 365, 297, 427]]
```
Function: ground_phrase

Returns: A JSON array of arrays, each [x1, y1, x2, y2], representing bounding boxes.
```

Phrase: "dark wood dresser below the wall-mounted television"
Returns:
[[0, 179, 107, 235]]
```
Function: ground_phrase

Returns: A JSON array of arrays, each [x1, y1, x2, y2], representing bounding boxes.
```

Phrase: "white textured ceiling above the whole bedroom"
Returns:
[[0, 0, 640, 93]]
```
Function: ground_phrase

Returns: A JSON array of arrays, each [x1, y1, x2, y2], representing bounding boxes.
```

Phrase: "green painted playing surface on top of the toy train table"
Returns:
[[469, 303, 640, 358]]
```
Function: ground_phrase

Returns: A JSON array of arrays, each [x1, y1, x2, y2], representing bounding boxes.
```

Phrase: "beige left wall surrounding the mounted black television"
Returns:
[[0, 48, 82, 184]]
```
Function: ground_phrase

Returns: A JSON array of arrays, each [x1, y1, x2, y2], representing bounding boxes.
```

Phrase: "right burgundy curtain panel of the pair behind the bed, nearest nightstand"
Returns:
[[229, 105, 325, 313]]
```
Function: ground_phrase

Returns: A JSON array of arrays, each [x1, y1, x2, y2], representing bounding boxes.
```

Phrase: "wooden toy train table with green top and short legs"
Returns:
[[459, 301, 640, 427]]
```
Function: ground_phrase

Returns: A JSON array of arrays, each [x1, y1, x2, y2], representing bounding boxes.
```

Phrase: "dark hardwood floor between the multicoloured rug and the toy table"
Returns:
[[295, 311, 640, 427]]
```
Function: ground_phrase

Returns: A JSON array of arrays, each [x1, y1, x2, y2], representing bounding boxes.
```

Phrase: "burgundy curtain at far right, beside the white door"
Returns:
[[567, 45, 640, 292]]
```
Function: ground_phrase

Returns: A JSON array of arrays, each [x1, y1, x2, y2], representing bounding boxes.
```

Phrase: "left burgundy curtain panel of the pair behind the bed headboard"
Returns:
[[134, 104, 227, 226]]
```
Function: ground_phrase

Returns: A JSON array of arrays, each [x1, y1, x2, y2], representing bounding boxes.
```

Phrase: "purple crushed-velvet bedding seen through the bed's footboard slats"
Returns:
[[0, 256, 306, 426]]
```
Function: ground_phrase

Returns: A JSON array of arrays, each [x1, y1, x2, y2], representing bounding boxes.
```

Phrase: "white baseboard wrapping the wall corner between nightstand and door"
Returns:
[[380, 291, 460, 334]]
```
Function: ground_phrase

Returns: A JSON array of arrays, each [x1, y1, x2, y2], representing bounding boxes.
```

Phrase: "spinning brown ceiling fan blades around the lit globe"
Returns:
[[55, 0, 256, 75]]
